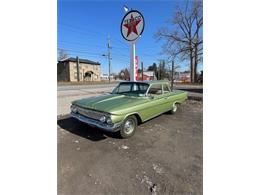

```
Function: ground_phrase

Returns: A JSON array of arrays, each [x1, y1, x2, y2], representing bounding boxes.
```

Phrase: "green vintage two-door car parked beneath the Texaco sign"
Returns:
[[71, 81, 187, 138]]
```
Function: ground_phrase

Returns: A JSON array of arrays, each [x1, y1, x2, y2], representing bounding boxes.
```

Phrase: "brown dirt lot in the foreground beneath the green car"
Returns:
[[58, 101, 203, 195]]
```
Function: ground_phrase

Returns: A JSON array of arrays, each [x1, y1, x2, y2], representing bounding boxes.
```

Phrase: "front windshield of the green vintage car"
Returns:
[[112, 82, 149, 96]]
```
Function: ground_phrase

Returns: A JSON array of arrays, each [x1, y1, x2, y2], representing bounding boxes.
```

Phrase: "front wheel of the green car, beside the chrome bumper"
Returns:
[[119, 115, 137, 138]]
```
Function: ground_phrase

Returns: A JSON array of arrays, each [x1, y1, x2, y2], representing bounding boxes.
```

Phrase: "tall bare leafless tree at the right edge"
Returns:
[[156, 0, 203, 82]]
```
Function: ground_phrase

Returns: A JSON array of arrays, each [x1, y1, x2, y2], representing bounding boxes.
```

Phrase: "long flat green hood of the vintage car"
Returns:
[[72, 94, 147, 114]]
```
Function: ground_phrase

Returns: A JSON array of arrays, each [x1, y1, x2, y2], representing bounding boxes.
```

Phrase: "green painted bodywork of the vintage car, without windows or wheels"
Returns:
[[72, 81, 187, 123]]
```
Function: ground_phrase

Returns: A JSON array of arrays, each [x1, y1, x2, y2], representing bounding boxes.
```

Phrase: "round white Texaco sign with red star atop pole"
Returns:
[[121, 10, 144, 41]]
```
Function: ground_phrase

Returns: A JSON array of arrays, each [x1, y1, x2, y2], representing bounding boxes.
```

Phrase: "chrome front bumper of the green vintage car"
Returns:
[[70, 112, 121, 132]]
